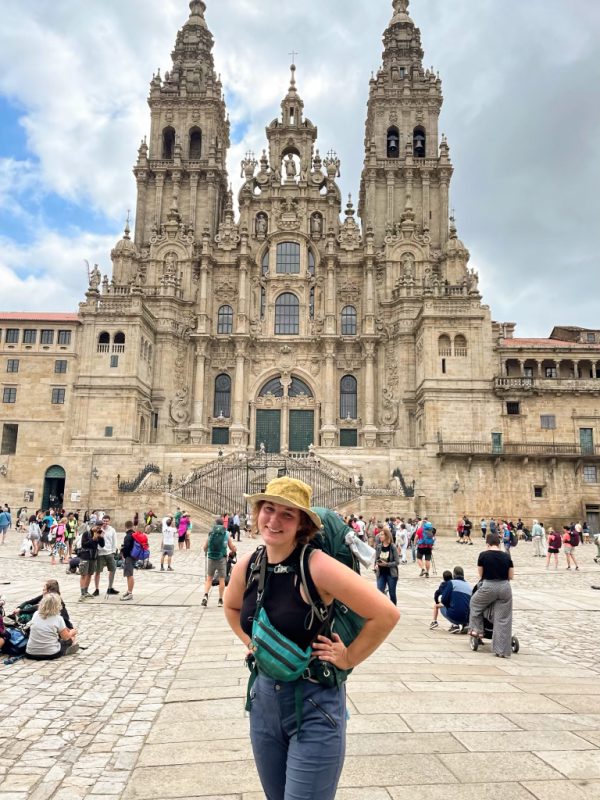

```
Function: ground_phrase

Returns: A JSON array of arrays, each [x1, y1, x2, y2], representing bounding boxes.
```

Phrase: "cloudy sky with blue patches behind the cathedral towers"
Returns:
[[0, 0, 600, 337]]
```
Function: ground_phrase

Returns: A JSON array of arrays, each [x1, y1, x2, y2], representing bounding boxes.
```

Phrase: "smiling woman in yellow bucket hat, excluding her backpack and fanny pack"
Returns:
[[225, 477, 400, 800]]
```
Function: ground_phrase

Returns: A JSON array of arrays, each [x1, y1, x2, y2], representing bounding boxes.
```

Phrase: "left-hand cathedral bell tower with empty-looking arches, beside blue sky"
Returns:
[[133, 0, 229, 249]]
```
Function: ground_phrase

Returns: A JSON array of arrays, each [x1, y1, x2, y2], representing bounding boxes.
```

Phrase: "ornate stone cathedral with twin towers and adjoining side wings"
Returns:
[[0, 0, 600, 528]]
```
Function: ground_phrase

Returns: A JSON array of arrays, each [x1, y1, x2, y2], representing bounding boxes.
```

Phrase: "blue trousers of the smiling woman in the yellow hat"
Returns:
[[250, 675, 346, 800]]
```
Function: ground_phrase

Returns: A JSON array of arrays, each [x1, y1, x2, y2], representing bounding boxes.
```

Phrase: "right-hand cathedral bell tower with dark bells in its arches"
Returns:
[[359, 0, 452, 250]]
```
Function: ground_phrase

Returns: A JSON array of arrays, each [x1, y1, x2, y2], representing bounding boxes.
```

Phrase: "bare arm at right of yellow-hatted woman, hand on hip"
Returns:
[[310, 550, 400, 669]]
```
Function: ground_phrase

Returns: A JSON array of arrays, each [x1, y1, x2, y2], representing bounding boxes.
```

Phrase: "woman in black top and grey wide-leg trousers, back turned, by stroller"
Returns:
[[469, 533, 515, 658]]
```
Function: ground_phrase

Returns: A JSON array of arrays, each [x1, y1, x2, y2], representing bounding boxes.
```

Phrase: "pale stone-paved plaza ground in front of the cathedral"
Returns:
[[0, 533, 600, 800]]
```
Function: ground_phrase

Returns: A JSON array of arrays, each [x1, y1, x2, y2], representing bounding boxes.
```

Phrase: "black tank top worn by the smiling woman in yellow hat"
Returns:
[[240, 547, 323, 649]]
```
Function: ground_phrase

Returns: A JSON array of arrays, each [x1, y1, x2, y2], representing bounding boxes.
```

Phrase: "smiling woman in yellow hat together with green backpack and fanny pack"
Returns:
[[225, 477, 400, 800]]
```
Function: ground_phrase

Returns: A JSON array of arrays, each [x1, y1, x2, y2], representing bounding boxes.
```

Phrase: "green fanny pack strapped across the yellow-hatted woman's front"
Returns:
[[250, 607, 313, 681]]
